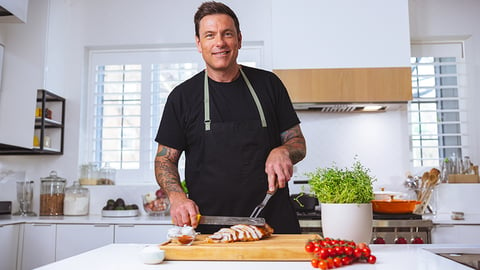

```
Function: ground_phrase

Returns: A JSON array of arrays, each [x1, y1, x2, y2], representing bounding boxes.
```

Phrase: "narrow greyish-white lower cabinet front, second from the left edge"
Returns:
[[20, 223, 55, 270]]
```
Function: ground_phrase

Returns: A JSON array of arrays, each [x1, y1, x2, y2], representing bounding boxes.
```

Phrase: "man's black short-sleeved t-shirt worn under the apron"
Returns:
[[155, 66, 300, 154]]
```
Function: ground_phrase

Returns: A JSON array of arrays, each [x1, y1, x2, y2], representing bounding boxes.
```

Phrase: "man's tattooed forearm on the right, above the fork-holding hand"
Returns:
[[280, 125, 306, 164]]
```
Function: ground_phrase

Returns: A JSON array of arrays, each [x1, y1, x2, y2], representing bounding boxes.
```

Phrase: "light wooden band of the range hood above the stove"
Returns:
[[273, 67, 412, 103]]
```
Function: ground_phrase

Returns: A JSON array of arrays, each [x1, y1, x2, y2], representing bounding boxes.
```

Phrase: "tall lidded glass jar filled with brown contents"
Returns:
[[40, 171, 66, 216]]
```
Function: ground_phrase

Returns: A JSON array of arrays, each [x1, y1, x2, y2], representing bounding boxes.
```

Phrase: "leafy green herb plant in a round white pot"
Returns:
[[307, 157, 376, 243]]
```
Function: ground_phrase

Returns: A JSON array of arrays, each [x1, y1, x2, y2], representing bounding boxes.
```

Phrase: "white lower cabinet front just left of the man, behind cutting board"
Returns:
[[115, 225, 172, 244]]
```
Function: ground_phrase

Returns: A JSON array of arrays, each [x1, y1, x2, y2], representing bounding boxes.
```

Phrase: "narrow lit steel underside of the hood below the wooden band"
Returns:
[[293, 102, 406, 113]]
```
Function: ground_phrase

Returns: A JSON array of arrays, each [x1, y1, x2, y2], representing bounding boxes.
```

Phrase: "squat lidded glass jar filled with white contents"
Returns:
[[63, 181, 90, 216]]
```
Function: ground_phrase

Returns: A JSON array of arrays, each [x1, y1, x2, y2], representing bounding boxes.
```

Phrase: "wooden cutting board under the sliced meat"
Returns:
[[160, 234, 320, 261]]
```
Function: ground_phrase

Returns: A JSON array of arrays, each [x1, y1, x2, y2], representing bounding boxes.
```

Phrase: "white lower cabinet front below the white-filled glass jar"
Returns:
[[55, 224, 114, 261]]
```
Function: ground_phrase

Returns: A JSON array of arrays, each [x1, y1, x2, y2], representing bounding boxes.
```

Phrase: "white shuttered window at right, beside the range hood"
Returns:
[[408, 43, 467, 167]]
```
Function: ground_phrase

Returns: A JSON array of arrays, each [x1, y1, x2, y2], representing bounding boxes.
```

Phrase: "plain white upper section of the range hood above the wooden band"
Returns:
[[272, 0, 410, 69]]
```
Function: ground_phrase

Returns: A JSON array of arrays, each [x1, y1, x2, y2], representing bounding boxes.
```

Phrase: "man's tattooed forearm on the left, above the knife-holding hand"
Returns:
[[155, 145, 183, 194]]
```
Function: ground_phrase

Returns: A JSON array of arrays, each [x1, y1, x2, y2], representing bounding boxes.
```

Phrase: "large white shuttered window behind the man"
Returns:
[[81, 44, 262, 184]]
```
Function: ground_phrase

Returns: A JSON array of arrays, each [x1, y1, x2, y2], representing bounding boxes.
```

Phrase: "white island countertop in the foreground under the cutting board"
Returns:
[[37, 244, 480, 270]]
